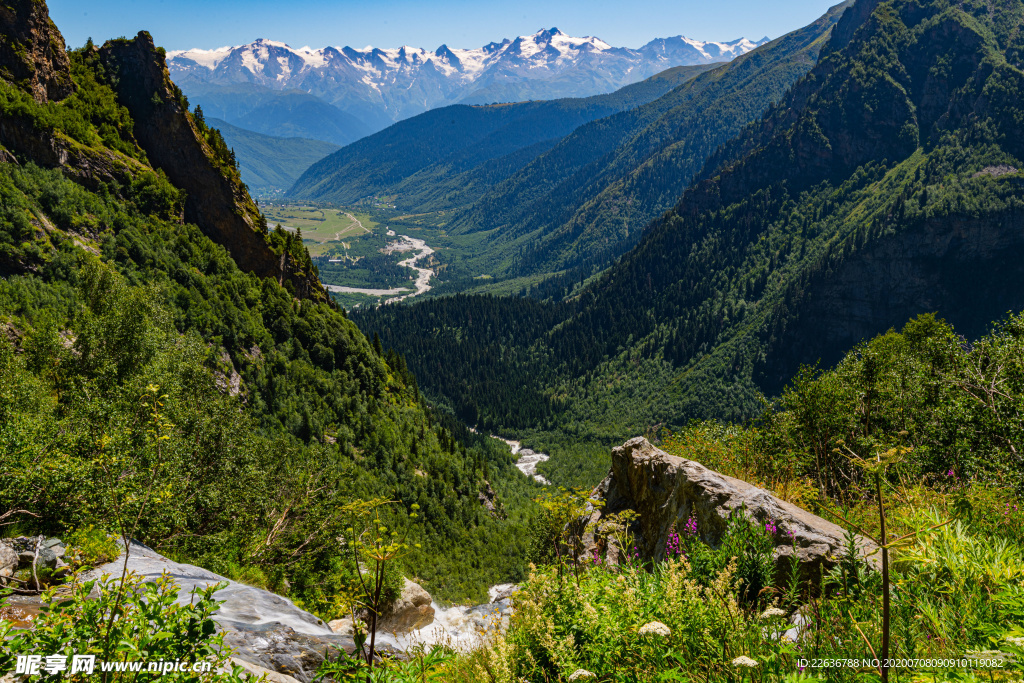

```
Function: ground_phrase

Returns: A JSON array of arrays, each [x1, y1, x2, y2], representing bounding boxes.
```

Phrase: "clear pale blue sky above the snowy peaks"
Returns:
[[49, 0, 835, 50]]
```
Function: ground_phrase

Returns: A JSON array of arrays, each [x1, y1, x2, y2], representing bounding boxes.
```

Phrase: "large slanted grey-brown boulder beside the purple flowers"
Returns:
[[591, 437, 880, 580]]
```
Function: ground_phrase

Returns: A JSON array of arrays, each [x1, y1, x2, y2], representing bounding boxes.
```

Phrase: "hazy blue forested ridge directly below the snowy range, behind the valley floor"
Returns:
[[289, 65, 711, 206]]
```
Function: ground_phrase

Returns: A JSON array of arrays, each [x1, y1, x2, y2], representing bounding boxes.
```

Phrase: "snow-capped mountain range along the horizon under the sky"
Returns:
[[167, 29, 767, 129]]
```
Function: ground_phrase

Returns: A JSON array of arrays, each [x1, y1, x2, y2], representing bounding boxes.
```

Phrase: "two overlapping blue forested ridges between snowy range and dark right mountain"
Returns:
[[286, 3, 849, 283]]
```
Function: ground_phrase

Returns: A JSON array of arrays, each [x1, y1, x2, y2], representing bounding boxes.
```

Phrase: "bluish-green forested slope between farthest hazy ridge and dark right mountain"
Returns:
[[450, 2, 850, 275]]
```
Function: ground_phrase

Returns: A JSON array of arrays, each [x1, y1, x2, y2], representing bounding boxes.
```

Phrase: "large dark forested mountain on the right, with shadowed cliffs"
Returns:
[[357, 0, 1024, 454]]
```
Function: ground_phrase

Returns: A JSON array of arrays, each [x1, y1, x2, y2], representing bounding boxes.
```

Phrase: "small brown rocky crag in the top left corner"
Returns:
[[0, 0, 75, 103]]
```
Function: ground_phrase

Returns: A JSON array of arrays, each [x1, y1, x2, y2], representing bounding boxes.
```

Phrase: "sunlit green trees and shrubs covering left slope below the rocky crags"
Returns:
[[0, 105, 530, 611]]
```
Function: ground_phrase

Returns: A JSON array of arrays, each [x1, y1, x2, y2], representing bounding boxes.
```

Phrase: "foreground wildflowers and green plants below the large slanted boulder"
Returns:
[[446, 510, 1024, 683]]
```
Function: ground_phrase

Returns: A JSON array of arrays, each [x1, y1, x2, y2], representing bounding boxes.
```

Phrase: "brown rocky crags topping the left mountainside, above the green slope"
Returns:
[[0, 0, 327, 300]]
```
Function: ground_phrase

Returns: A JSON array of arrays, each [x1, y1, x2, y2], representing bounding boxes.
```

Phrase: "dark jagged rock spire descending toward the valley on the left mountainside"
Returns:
[[100, 31, 327, 300]]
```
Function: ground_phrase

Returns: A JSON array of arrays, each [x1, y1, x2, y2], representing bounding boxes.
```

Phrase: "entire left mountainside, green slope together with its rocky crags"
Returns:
[[0, 0, 531, 618]]
